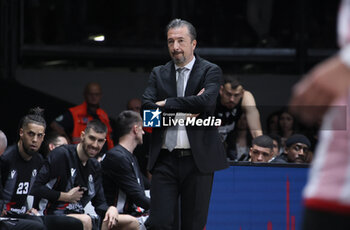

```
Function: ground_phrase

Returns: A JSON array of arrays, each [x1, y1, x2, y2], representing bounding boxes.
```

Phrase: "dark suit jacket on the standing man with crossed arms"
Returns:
[[142, 55, 228, 173]]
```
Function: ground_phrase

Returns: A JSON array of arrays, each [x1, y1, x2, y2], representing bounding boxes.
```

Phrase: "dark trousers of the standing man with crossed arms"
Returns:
[[147, 150, 214, 230]]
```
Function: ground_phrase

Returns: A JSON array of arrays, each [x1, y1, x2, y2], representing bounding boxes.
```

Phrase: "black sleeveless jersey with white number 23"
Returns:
[[0, 144, 44, 214]]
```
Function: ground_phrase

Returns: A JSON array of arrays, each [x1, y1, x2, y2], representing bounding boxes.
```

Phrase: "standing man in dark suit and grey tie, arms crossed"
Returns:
[[142, 19, 228, 230]]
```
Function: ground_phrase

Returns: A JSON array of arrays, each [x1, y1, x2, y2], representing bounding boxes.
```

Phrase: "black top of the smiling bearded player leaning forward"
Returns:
[[33, 145, 108, 216]]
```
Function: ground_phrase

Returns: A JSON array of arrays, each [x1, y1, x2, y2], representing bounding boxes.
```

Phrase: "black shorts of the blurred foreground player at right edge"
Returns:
[[302, 208, 350, 230]]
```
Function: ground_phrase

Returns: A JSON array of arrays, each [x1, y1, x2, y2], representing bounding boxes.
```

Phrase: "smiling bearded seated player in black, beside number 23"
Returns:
[[33, 120, 139, 230]]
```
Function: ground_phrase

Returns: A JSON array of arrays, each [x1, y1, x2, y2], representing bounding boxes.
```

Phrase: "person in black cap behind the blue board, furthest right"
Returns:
[[271, 134, 312, 164]]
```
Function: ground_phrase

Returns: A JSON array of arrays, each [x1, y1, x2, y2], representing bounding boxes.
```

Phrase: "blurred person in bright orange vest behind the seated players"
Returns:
[[50, 82, 114, 153]]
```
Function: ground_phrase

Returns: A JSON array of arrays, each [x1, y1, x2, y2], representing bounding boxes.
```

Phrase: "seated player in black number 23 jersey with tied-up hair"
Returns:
[[0, 107, 46, 229]]
